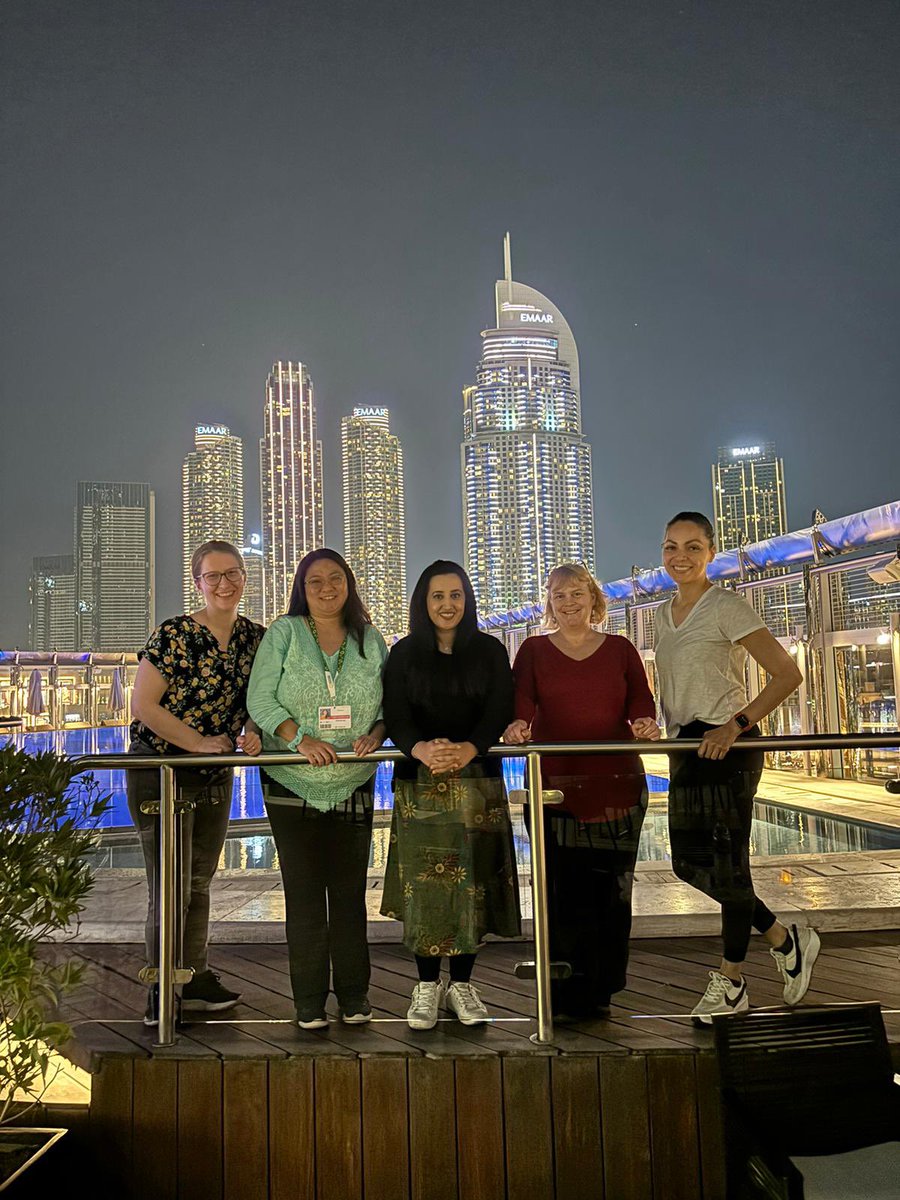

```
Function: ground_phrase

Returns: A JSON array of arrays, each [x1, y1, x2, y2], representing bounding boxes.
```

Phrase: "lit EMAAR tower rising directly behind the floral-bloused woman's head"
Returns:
[[181, 425, 244, 612]]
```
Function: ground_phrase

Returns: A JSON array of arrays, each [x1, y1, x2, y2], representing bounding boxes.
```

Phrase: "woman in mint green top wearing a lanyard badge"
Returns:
[[247, 548, 388, 1030]]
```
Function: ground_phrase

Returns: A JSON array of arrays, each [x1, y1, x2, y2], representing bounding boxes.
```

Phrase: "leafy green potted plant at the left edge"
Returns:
[[0, 745, 109, 1194]]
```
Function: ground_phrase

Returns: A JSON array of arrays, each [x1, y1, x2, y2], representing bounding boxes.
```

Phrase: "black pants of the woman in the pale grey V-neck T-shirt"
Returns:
[[668, 721, 775, 962]]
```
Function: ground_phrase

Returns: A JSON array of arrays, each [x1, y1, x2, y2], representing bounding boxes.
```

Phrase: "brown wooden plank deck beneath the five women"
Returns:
[[45, 932, 900, 1200]]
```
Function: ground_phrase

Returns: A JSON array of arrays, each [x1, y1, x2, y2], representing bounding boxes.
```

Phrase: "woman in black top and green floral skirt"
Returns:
[[382, 560, 520, 1030]]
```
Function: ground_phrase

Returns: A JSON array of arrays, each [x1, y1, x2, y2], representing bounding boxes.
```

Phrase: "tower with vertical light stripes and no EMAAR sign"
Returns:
[[259, 362, 325, 623]]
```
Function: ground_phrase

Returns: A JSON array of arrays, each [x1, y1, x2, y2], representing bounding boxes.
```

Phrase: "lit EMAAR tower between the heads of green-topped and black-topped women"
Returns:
[[341, 406, 408, 636]]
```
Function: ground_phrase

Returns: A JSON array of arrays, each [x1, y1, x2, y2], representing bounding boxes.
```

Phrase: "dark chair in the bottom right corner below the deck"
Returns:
[[713, 1004, 900, 1200]]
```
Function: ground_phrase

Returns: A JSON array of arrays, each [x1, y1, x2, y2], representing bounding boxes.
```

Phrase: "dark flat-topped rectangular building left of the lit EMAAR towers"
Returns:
[[74, 482, 156, 652]]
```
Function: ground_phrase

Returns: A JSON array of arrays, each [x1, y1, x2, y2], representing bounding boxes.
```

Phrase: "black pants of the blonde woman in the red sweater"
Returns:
[[526, 791, 647, 1016]]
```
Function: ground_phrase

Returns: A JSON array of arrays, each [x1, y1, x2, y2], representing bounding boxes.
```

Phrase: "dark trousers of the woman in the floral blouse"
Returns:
[[126, 748, 234, 974]]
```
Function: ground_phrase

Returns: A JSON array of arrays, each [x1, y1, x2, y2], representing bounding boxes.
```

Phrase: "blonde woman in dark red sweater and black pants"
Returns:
[[503, 563, 660, 1019]]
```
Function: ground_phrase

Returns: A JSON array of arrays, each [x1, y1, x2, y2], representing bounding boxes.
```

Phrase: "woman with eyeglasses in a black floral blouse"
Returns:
[[127, 540, 264, 1025]]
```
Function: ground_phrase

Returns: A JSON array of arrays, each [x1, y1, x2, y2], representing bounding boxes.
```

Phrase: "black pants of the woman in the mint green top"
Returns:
[[265, 781, 372, 1013]]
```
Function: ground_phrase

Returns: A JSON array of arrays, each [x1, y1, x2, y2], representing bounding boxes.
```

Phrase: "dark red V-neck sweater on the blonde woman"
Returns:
[[512, 634, 656, 821]]
